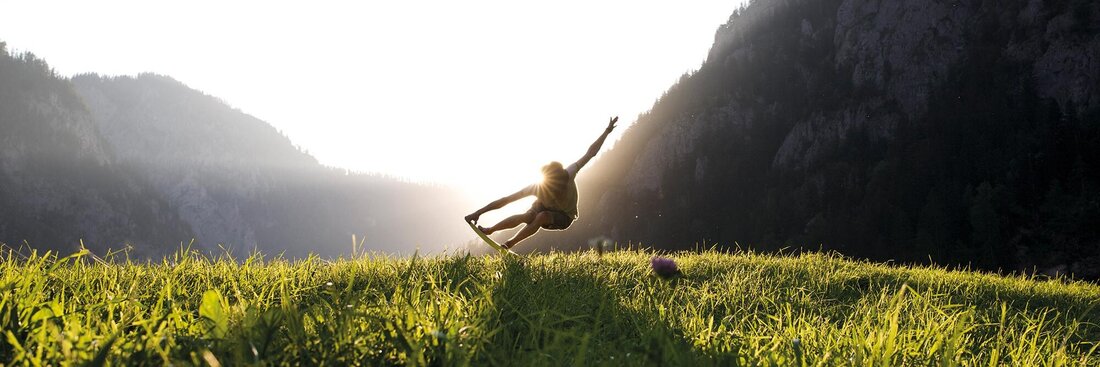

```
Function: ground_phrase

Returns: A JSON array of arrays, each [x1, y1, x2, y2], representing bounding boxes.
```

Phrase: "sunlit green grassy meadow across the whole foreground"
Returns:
[[0, 251, 1100, 366]]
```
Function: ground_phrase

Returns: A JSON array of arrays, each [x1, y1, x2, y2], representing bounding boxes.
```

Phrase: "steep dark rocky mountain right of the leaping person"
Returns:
[[539, 0, 1100, 278]]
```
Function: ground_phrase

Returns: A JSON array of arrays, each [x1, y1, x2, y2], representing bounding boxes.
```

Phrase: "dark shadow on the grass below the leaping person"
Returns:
[[485, 259, 715, 366]]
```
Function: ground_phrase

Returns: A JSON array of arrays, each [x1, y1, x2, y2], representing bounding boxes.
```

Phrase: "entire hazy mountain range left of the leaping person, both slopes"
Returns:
[[0, 43, 471, 257]]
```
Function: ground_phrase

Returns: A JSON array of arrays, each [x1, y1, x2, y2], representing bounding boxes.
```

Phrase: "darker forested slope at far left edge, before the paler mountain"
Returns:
[[0, 43, 193, 256]]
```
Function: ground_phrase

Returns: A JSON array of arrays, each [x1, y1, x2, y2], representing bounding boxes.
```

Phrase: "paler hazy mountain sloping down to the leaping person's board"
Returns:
[[73, 74, 470, 256]]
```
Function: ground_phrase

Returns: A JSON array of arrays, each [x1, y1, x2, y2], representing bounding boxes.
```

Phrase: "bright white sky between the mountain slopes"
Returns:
[[0, 0, 743, 200]]
